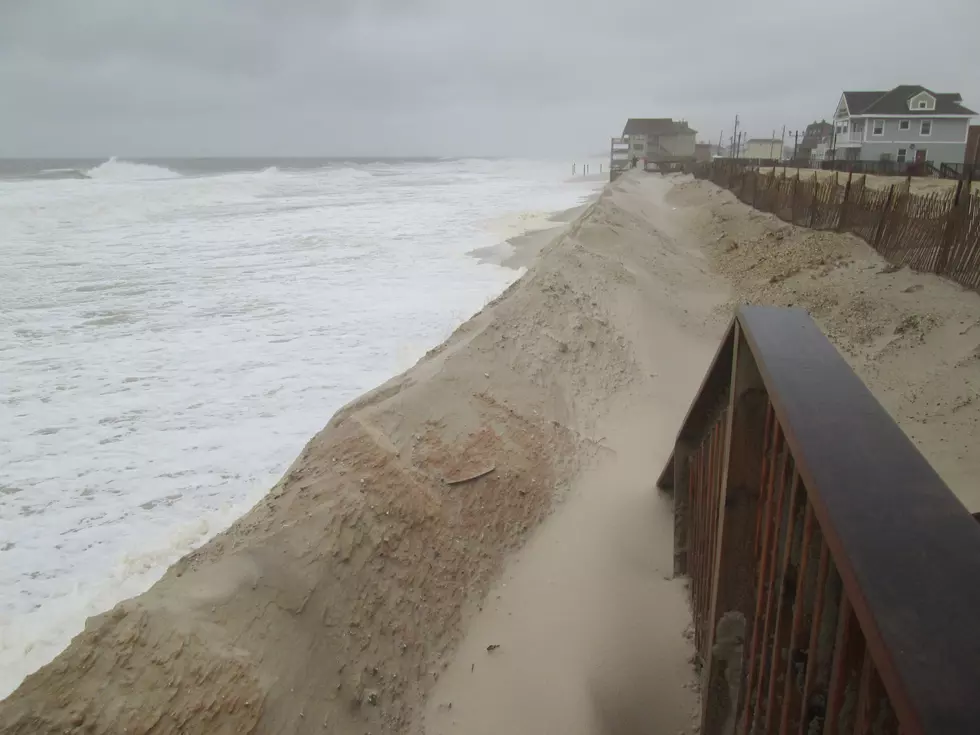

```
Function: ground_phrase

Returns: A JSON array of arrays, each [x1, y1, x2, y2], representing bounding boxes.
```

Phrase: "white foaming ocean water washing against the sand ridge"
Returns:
[[0, 159, 597, 696]]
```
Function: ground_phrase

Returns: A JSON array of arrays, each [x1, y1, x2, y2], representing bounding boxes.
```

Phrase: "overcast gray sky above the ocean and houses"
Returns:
[[0, 0, 980, 156]]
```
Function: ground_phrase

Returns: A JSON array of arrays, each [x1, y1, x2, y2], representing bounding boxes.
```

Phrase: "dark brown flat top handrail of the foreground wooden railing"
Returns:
[[659, 306, 980, 735]]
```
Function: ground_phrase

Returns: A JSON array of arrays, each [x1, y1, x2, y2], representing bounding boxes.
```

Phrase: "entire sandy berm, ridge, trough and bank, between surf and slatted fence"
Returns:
[[0, 173, 980, 735]]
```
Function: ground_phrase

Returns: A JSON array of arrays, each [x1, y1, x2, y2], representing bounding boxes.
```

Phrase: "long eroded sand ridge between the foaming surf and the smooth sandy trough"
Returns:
[[0, 177, 717, 735]]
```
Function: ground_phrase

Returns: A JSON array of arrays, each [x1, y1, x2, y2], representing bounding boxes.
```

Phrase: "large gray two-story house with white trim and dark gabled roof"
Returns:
[[832, 84, 977, 166]]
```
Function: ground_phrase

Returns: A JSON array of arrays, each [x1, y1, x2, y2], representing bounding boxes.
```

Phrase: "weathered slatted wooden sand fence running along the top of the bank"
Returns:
[[692, 159, 980, 290]]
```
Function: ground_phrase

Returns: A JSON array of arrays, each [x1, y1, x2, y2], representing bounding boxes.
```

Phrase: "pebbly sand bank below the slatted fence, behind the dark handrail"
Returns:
[[668, 177, 980, 512]]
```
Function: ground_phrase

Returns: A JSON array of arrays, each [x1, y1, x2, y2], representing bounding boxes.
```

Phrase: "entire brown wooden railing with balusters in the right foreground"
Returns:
[[658, 307, 980, 735]]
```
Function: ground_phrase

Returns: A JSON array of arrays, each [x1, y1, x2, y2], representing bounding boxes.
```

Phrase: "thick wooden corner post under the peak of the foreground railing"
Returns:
[[701, 325, 768, 735]]
